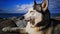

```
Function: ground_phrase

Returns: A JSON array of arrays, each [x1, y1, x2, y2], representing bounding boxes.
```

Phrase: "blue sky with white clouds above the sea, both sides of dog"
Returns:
[[0, 0, 60, 13]]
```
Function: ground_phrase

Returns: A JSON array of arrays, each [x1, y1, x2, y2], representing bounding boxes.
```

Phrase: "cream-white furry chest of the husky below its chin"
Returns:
[[26, 22, 43, 34]]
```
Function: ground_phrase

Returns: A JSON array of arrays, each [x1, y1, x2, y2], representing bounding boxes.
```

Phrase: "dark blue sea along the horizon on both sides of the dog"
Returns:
[[0, 13, 60, 18]]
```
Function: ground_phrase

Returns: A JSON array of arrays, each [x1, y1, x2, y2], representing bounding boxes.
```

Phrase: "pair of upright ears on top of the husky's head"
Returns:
[[33, 0, 48, 12]]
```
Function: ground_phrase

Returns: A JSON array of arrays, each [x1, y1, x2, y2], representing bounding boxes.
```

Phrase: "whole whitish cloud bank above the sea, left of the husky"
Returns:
[[0, 3, 33, 13]]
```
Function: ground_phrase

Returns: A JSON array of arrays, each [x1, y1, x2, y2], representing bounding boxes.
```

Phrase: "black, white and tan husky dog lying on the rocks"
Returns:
[[3, 0, 60, 34]]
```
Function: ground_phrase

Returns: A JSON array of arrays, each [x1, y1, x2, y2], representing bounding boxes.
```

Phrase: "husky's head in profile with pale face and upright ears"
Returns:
[[20, 0, 49, 25]]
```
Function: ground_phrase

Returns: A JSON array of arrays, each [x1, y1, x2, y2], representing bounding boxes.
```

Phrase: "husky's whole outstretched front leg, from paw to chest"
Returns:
[[2, 27, 28, 34]]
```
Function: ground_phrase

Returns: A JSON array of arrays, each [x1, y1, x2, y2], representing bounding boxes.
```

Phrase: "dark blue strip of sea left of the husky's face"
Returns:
[[0, 13, 25, 18]]
